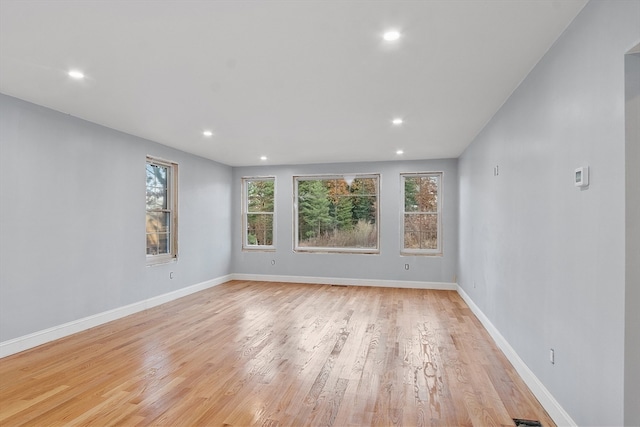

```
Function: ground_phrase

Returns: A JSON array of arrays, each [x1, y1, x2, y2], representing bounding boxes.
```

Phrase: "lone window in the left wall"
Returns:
[[146, 157, 178, 264]]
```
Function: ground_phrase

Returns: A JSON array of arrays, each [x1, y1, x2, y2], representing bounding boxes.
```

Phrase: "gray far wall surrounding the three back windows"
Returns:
[[232, 159, 458, 283]]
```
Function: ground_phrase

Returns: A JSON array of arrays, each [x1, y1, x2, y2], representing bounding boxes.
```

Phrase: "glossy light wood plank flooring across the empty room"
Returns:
[[0, 281, 554, 427]]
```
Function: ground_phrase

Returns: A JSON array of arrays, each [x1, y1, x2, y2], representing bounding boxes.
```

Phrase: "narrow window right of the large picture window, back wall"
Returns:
[[401, 172, 442, 255]]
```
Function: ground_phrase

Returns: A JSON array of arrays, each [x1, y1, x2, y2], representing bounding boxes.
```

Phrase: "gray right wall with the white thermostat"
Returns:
[[458, 1, 640, 425]]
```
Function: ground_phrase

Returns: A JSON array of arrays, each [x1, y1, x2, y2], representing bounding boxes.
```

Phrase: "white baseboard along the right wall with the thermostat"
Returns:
[[458, 286, 578, 427]]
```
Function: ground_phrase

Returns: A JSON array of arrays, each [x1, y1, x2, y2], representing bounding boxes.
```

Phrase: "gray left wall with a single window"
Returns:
[[0, 95, 232, 342]]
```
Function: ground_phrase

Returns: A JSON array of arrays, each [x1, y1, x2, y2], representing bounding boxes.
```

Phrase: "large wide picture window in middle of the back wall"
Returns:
[[294, 174, 379, 253]]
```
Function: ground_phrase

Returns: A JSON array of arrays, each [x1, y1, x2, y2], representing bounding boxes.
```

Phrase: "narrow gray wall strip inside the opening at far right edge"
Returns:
[[624, 49, 640, 426]]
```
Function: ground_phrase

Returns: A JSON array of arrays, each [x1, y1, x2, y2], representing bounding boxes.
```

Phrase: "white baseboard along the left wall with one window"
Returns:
[[0, 275, 231, 357]]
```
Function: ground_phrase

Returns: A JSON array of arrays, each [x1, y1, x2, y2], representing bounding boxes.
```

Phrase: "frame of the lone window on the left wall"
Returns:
[[145, 156, 178, 266]]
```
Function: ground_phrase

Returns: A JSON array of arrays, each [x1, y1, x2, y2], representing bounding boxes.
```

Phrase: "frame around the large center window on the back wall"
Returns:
[[293, 173, 381, 254]]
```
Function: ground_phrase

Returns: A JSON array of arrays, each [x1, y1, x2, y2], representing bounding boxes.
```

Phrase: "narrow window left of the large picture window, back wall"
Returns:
[[242, 177, 275, 250]]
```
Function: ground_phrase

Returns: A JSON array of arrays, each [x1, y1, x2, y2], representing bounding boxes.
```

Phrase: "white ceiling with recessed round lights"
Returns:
[[0, 0, 586, 166]]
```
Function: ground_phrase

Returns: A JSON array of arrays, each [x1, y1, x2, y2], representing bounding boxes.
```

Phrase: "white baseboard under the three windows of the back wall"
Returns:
[[231, 273, 458, 291]]
